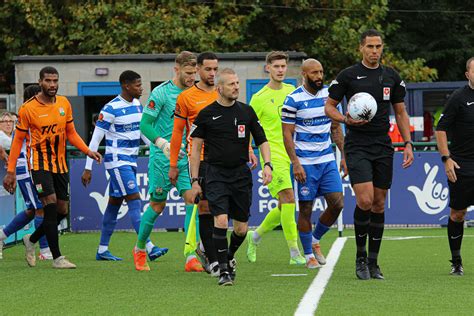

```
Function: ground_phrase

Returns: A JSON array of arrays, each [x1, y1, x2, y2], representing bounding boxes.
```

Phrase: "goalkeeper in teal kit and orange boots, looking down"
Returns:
[[133, 51, 204, 272]]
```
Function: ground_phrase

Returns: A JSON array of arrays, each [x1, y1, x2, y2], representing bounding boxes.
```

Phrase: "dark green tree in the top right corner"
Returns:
[[387, 0, 474, 81]]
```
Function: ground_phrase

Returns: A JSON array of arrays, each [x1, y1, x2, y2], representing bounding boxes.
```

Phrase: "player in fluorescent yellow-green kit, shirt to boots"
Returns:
[[247, 51, 306, 265]]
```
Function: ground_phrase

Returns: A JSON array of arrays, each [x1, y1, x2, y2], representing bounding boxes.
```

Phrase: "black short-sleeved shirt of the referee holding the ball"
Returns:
[[329, 62, 405, 135]]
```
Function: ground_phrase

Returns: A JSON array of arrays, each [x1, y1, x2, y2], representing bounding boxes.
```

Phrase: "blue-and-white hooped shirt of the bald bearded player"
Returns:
[[281, 86, 335, 165]]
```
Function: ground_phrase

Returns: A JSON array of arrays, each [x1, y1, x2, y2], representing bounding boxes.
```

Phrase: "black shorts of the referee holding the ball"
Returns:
[[344, 132, 394, 189]]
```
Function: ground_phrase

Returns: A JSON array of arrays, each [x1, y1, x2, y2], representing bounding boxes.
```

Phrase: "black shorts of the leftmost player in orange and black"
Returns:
[[31, 170, 69, 201]]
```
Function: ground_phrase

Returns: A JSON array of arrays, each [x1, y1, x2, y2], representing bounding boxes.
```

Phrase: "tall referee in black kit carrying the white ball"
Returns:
[[325, 29, 413, 280]]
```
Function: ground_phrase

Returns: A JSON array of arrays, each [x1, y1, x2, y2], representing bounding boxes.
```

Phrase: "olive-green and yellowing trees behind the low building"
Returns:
[[0, 0, 436, 92]]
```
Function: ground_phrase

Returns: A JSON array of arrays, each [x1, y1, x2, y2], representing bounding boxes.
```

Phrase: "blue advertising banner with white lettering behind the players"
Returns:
[[70, 152, 472, 231]]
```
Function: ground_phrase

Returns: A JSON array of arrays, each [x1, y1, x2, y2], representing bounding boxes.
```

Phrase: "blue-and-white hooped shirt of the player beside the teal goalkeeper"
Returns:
[[96, 95, 143, 169]]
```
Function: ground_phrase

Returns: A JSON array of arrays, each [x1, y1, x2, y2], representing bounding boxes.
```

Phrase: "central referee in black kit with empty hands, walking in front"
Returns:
[[190, 68, 273, 285]]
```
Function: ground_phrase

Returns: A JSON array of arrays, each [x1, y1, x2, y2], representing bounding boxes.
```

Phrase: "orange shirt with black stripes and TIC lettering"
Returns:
[[16, 96, 73, 173]]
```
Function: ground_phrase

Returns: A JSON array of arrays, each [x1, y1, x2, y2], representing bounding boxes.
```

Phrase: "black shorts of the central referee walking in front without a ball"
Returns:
[[206, 165, 253, 223]]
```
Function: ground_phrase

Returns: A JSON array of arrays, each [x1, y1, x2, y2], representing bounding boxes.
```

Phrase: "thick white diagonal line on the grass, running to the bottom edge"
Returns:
[[295, 237, 347, 316]]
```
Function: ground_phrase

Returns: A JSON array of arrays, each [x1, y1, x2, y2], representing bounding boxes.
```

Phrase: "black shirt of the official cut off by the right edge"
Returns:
[[436, 85, 474, 163]]
